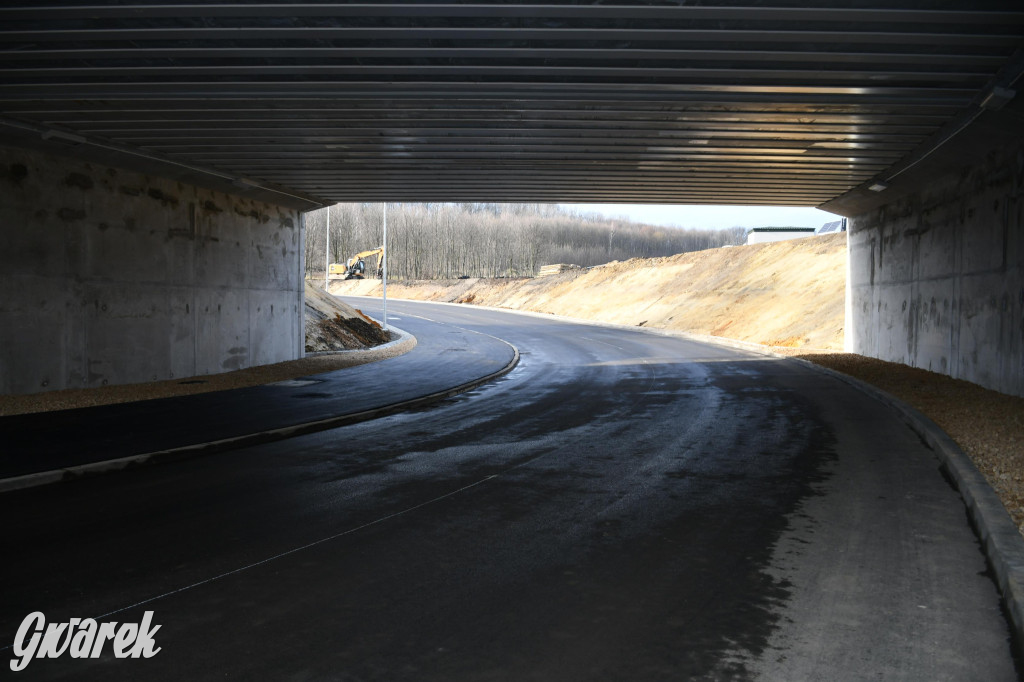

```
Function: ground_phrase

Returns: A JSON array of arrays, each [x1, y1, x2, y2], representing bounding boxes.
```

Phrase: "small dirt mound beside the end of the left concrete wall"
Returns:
[[305, 282, 390, 353]]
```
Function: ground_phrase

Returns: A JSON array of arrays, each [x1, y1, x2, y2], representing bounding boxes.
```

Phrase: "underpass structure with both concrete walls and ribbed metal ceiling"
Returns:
[[0, 3, 1024, 395]]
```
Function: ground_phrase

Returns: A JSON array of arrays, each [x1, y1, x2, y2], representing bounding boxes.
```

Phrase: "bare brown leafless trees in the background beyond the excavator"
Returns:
[[305, 203, 746, 280]]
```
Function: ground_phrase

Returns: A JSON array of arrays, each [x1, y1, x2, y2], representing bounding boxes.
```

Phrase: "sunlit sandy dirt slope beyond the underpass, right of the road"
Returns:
[[331, 233, 846, 350]]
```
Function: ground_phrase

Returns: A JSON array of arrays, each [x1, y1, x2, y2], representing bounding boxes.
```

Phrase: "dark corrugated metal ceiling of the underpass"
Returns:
[[0, 1, 1024, 205]]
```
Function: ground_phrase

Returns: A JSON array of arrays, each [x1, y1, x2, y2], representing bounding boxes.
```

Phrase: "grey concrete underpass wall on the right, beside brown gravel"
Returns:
[[846, 139, 1024, 395]]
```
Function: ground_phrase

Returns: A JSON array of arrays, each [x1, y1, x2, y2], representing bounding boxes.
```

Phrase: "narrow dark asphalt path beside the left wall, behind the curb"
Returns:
[[0, 307, 514, 478]]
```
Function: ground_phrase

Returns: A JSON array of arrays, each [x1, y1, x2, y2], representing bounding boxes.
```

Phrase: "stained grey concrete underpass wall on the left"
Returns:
[[0, 147, 303, 393]]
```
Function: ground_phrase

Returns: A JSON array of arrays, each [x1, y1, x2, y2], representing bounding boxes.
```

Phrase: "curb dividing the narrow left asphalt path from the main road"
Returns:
[[0, 327, 519, 494]]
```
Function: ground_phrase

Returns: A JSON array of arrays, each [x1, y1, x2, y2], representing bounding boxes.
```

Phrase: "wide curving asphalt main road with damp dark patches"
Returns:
[[0, 301, 1018, 682]]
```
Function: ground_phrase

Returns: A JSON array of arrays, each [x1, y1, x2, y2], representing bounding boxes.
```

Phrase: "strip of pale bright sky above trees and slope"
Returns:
[[561, 204, 840, 229]]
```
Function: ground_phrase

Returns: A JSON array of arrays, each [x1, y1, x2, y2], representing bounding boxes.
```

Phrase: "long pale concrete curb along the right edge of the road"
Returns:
[[346, 294, 1024, 647]]
